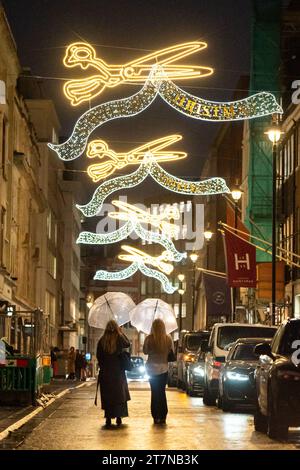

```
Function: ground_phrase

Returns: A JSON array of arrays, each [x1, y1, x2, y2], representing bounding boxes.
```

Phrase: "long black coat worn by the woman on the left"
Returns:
[[97, 335, 130, 410]]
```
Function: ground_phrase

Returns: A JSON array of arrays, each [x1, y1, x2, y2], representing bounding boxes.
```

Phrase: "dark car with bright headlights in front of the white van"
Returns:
[[218, 338, 271, 411]]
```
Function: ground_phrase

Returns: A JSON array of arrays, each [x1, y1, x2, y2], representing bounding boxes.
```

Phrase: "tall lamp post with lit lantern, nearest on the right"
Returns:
[[265, 125, 283, 325]]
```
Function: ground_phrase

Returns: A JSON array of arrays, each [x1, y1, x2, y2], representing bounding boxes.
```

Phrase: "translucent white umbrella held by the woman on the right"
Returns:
[[129, 299, 178, 334]]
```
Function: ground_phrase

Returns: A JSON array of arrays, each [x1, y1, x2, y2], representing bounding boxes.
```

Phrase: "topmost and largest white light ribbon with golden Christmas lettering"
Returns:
[[48, 67, 283, 161]]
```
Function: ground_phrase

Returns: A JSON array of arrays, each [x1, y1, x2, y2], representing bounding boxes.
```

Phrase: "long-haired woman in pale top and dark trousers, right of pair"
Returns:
[[143, 318, 173, 424]]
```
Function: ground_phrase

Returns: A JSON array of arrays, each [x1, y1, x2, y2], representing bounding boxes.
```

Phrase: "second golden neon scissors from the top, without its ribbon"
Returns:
[[86, 134, 187, 182]]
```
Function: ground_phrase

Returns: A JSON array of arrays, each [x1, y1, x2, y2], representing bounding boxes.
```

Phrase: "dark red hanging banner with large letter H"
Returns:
[[225, 230, 256, 287]]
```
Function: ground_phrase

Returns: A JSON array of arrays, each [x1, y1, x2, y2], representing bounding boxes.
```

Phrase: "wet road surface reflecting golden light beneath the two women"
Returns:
[[0, 383, 300, 450]]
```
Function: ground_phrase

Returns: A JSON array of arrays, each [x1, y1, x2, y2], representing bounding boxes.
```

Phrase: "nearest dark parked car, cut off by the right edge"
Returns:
[[254, 319, 300, 438]]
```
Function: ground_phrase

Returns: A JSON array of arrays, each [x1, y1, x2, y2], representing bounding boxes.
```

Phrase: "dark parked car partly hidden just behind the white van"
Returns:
[[177, 330, 210, 390]]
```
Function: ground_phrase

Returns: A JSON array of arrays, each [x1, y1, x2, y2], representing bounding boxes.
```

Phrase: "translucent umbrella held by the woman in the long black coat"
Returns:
[[88, 292, 135, 329]]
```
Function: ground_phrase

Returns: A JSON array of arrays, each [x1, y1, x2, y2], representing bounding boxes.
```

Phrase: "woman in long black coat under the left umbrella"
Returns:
[[97, 320, 130, 427]]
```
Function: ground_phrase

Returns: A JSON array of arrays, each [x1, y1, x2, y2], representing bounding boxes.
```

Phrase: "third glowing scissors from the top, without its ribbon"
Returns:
[[108, 200, 180, 238]]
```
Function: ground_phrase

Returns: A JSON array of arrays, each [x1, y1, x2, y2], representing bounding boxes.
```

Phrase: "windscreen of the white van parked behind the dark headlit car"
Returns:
[[217, 325, 277, 349]]
